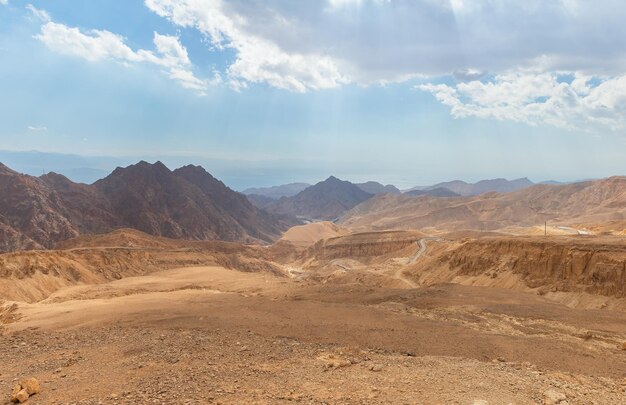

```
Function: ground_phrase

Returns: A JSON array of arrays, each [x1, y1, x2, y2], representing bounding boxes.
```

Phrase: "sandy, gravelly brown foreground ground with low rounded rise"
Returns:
[[0, 267, 626, 404]]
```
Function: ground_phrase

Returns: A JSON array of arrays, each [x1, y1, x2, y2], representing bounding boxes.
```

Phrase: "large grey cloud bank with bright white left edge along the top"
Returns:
[[144, 0, 626, 83]]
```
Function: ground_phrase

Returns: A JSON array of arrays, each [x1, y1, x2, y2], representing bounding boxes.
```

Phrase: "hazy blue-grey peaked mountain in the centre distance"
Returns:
[[267, 176, 372, 220]]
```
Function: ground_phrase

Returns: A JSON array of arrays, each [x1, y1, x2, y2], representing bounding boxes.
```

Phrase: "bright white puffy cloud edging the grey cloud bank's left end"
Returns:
[[145, 0, 349, 92]]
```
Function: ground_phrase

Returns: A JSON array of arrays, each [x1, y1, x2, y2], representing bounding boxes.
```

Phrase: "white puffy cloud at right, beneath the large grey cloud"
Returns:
[[417, 71, 626, 131]]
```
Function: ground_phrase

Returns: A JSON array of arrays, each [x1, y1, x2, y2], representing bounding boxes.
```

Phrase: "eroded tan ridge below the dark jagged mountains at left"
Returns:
[[0, 229, 282, 302]]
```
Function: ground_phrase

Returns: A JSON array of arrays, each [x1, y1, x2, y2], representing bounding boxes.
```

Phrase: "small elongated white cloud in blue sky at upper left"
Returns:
[[36, 21, 212, 94]]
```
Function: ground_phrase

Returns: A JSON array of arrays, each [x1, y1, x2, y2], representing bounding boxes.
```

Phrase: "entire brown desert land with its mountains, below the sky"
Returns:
[[0, 162, 626, 405]]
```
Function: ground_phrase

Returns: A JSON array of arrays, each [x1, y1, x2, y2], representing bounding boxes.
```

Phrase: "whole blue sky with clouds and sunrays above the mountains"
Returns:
[[0, 0, 626, 190]]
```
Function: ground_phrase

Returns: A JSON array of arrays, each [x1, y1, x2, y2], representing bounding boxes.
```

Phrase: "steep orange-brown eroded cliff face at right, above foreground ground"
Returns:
[[438, 238, 626, 297]]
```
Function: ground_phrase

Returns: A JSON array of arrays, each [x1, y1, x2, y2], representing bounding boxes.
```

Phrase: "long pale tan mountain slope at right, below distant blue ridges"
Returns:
[[339, 177, 626, 231]]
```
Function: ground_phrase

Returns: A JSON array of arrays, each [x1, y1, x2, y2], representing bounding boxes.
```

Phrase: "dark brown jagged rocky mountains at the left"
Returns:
[[0, 162, 295, 251]]
